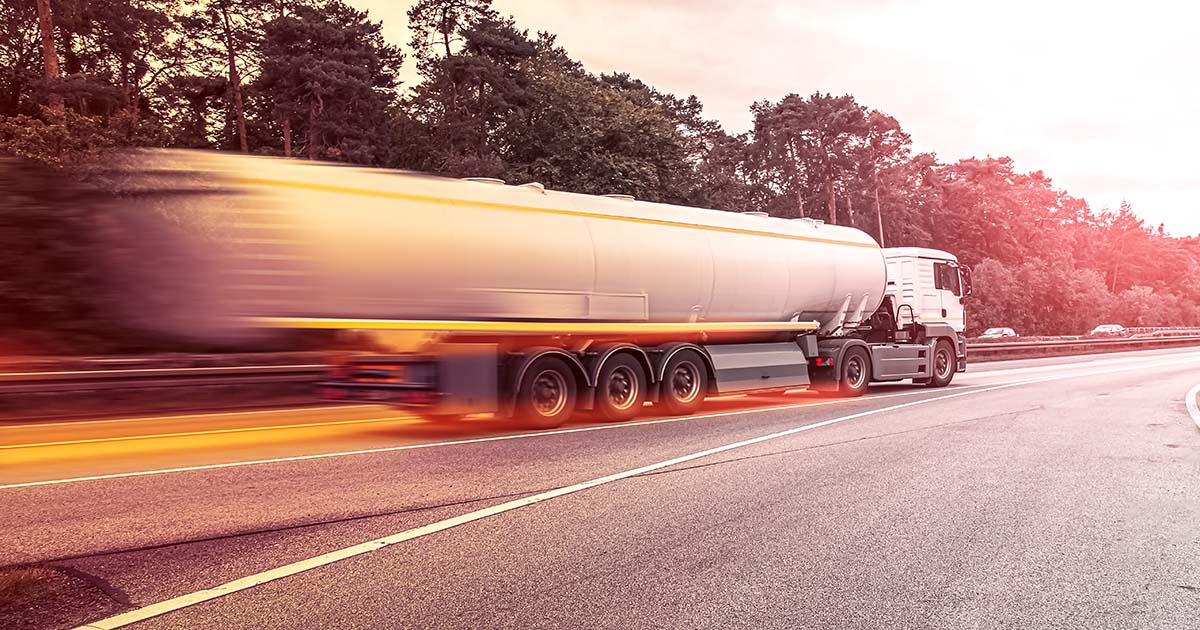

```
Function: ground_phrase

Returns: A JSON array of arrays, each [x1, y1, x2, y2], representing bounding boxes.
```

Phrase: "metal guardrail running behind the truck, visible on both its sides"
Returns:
[[0, 335, 1200, 395]]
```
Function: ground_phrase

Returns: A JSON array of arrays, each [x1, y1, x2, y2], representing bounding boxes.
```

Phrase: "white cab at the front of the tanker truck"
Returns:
[[883, 247, 971, 335]]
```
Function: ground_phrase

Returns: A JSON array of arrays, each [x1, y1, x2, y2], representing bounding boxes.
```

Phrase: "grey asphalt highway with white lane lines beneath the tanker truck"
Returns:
[[0, 349, 1200, 629]]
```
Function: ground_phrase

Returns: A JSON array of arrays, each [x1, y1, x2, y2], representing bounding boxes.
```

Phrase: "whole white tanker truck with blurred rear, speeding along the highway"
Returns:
[[98, 151, 971, 427]]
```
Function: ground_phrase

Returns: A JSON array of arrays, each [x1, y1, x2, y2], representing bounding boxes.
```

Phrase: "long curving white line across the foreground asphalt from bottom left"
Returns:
[[76, 358, 1200, 630]]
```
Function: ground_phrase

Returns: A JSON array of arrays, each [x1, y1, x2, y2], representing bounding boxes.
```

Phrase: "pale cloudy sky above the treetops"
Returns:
[[349, 0, 1200, 236]]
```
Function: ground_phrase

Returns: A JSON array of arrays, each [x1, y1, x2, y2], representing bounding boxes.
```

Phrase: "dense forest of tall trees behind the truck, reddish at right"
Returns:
[[0, 0, 1200, 348]]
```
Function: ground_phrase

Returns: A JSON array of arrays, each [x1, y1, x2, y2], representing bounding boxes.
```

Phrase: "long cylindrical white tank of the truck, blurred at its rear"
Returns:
[[96, 151, 886, 343]]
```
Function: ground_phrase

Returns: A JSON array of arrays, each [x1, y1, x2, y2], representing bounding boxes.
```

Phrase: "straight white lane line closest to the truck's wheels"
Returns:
[[0, 385, 950, 490]]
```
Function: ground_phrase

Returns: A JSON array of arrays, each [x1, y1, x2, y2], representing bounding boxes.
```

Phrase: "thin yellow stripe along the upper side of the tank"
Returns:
[[230, 176, 880, 250]]
